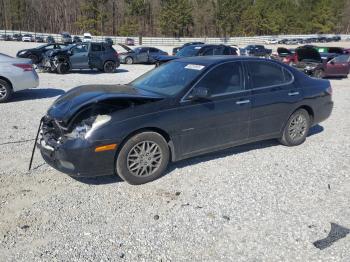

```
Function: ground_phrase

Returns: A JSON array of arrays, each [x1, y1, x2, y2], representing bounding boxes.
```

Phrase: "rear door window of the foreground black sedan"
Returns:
[[247, 61, 293, 88]]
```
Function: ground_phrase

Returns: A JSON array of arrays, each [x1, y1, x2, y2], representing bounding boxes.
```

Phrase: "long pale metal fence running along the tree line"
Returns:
[[0, 30, 350, 46]]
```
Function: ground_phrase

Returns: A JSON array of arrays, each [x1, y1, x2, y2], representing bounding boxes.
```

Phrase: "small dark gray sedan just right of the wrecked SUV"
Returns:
[[119, 44, 168, 65]]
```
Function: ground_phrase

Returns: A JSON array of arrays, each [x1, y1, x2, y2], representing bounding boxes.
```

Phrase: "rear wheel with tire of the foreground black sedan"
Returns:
[[279, 109, 311, 146]]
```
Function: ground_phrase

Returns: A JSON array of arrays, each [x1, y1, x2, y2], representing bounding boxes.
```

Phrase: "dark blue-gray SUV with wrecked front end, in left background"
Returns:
[[41, 42, 120, 74]]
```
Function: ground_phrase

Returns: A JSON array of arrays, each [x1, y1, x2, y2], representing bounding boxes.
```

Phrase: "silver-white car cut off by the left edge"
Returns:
[[0, 53, 39, 103]]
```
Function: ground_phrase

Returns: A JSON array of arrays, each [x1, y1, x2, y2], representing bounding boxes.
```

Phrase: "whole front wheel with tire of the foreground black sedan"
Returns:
[[116, 132, 170, 185]]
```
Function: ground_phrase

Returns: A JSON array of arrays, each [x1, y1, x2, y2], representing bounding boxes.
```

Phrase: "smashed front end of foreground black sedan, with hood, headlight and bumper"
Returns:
[[36, 86, 164, 177]]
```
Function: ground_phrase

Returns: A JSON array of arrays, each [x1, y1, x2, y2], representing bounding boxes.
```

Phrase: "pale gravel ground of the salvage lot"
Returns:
[[0, 42, 350, 261]]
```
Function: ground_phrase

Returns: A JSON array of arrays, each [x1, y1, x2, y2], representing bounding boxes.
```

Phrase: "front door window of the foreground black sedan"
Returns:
[[196, 62, 244, 96]]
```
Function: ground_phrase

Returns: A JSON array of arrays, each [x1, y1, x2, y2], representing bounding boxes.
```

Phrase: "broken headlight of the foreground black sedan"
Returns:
[[67, 115, 111, 139]]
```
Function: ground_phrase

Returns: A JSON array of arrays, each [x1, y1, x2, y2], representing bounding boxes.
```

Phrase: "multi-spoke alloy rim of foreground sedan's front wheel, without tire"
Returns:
[[127, 141, 163, 177]]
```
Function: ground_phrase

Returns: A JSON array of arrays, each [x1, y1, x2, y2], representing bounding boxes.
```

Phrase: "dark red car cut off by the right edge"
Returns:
[[313, 55, 350, 78]]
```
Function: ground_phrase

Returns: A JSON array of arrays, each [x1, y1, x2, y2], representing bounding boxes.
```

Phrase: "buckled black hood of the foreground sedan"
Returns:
[[47, 85, 164, 124]]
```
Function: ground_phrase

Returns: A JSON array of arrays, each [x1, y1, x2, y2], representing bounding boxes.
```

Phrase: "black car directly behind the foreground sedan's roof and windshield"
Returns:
[[154, 44, 237, 67]]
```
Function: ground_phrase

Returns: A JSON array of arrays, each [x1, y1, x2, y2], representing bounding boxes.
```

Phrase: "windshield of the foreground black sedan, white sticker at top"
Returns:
[[130, 61, 205, 96]]
